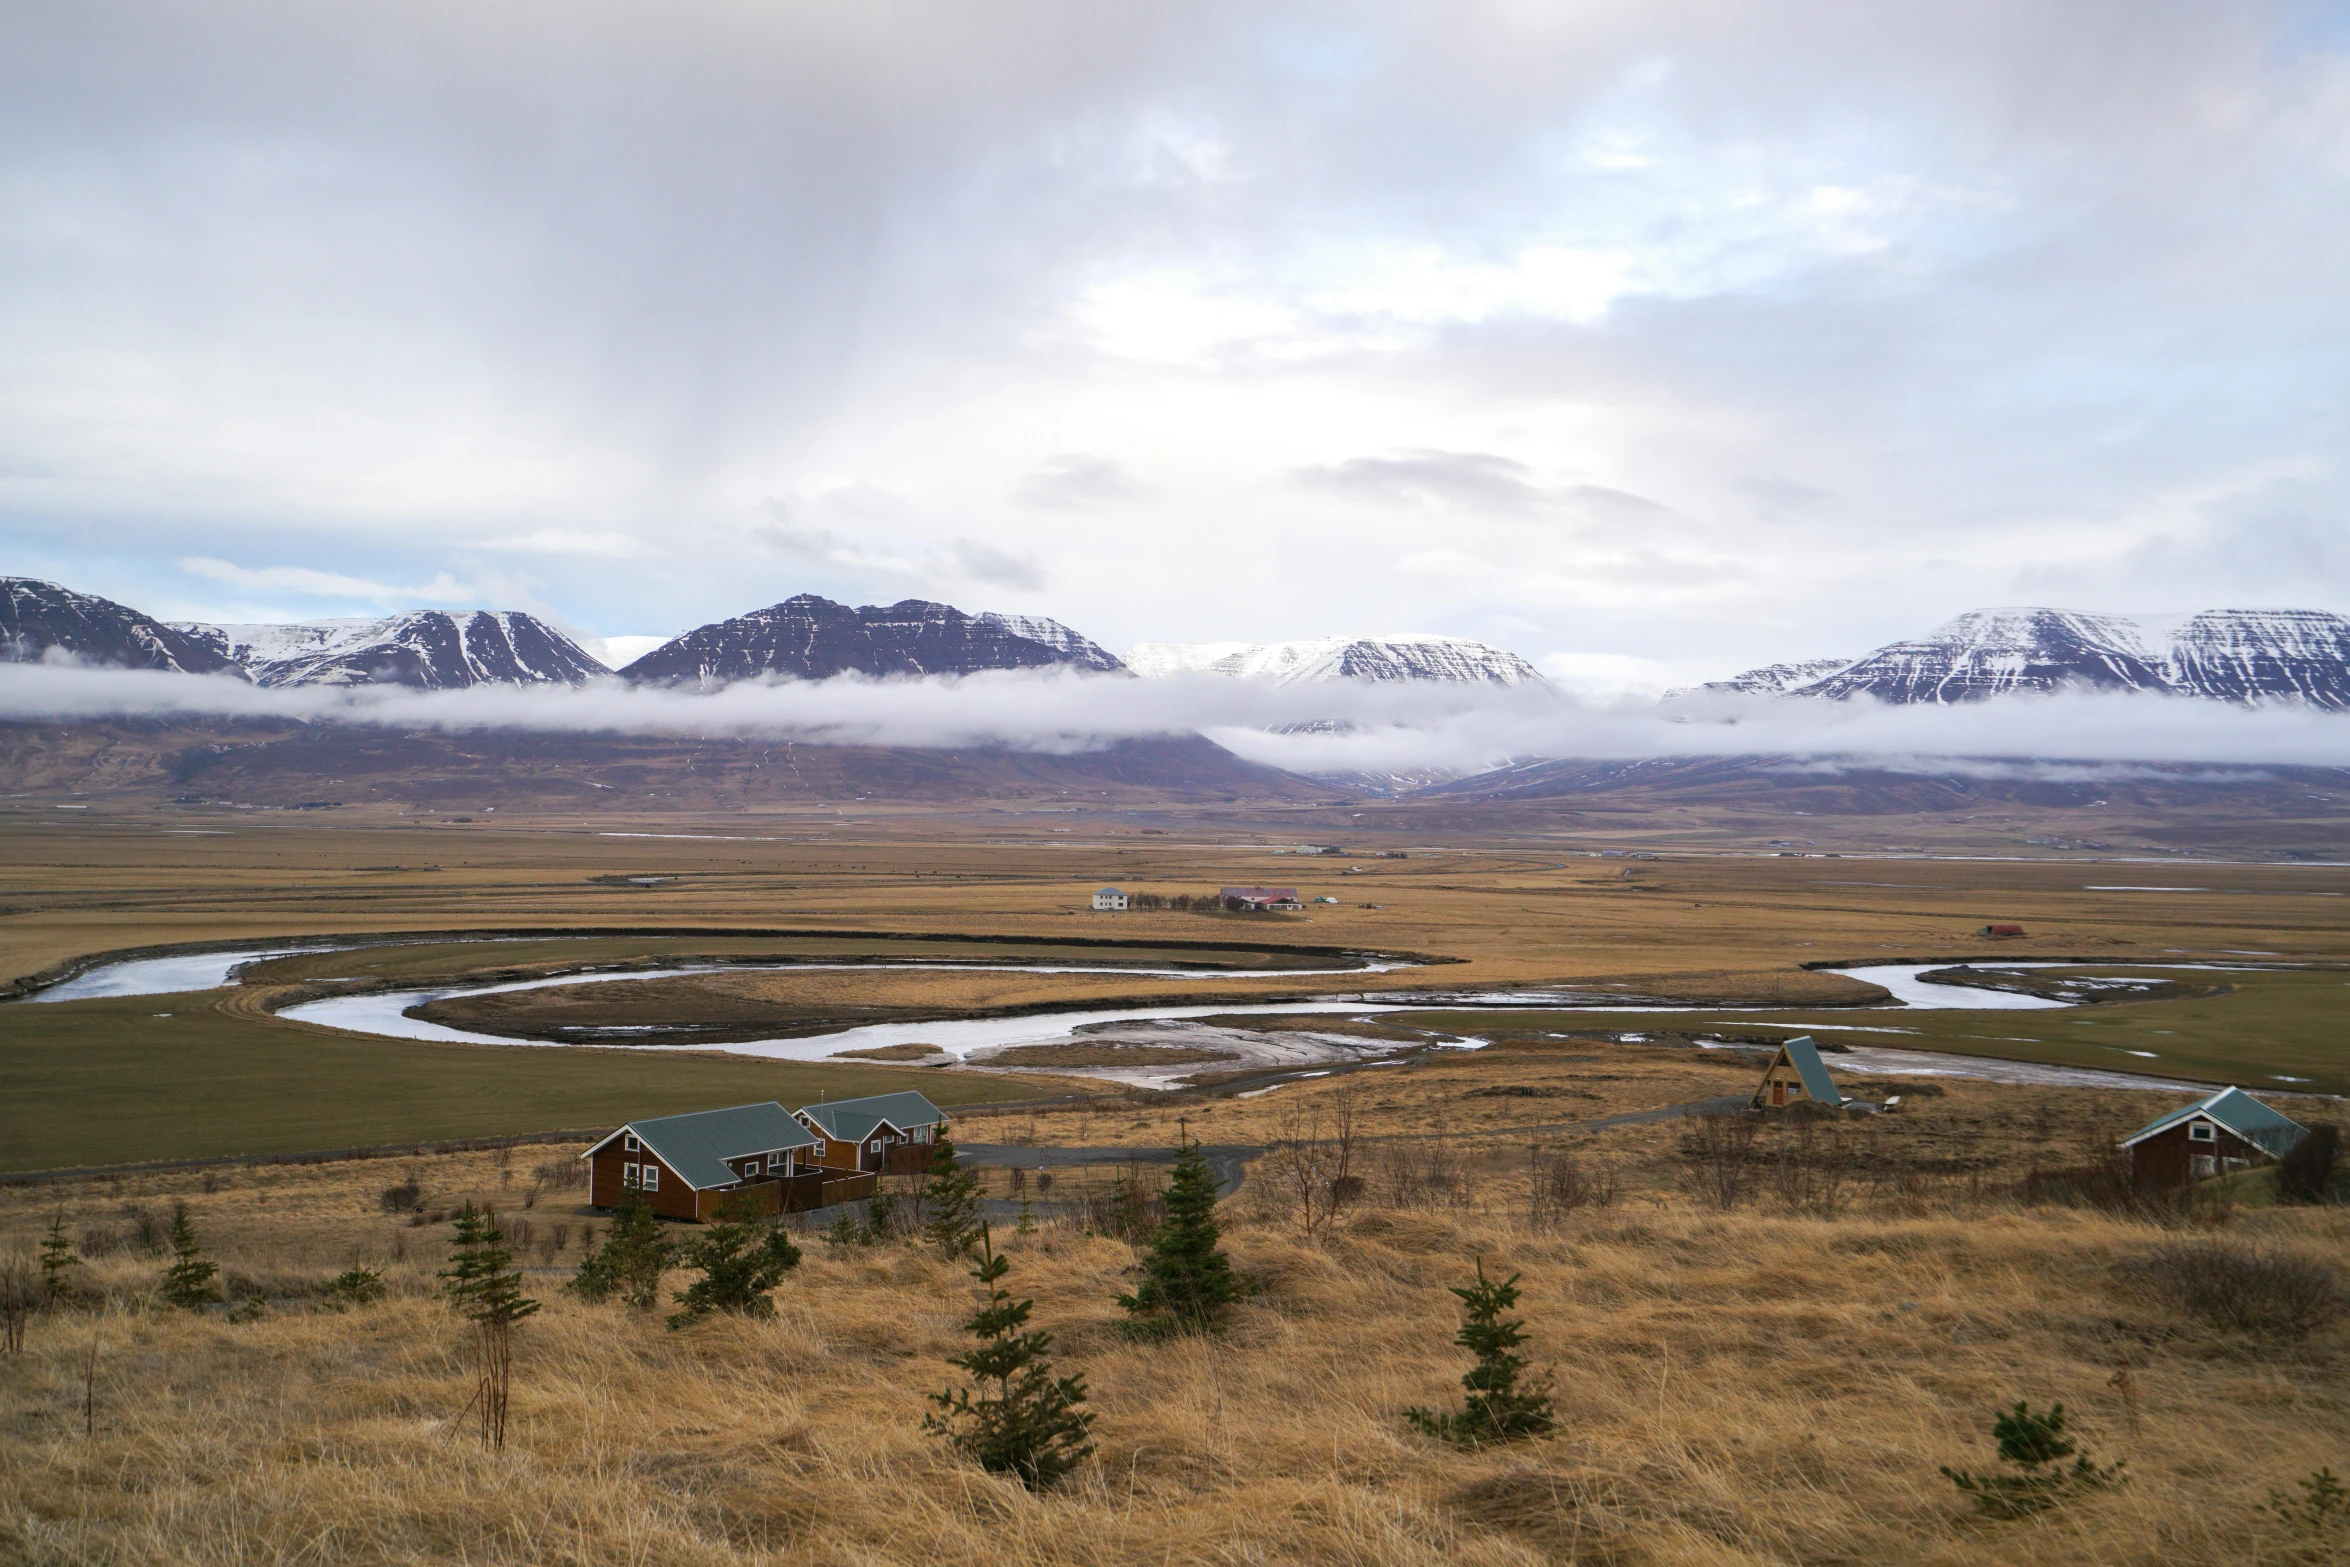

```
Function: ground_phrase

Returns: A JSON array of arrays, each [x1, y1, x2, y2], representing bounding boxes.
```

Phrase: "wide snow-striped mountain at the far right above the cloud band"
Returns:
[[1699, 608, 2350, 707]]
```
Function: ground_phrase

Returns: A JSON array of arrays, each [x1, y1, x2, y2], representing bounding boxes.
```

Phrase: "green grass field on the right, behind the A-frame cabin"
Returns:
[[1382, 963, 2350, 1095]]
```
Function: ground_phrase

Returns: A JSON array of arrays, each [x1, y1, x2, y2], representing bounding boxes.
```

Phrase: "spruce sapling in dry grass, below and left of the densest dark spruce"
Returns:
[[921, 1224, 1093, 1492]]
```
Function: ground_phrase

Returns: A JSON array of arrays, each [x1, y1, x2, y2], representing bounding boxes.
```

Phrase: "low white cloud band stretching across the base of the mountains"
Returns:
[[0, 665, 2350, 775]]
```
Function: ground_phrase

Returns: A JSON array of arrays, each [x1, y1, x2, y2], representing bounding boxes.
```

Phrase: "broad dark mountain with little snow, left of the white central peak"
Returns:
[[620, 592, 1116, 686]]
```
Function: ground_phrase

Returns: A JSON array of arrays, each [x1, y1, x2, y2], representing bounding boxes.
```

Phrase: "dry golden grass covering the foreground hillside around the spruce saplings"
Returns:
[[0, 1064, 2350, 1567]]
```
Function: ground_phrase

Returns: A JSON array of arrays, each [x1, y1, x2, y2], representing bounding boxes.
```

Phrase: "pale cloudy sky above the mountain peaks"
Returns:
[[0, 0, 2350, 693]]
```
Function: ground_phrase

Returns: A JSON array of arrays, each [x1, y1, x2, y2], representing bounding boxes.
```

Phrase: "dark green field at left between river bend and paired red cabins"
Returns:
[[0, 991, 1036, 1172]]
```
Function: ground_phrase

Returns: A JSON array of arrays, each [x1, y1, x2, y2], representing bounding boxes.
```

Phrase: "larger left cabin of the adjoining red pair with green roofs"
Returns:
[[580, 1099, 825, 1219]]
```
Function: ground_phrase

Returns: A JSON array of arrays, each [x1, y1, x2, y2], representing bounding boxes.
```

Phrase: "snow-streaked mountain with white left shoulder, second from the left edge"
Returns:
[[174, 608, 611, 691]]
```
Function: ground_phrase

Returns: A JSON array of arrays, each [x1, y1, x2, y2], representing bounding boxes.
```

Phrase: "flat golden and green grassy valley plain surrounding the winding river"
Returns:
[[0, 806, 2350, 1170]]
